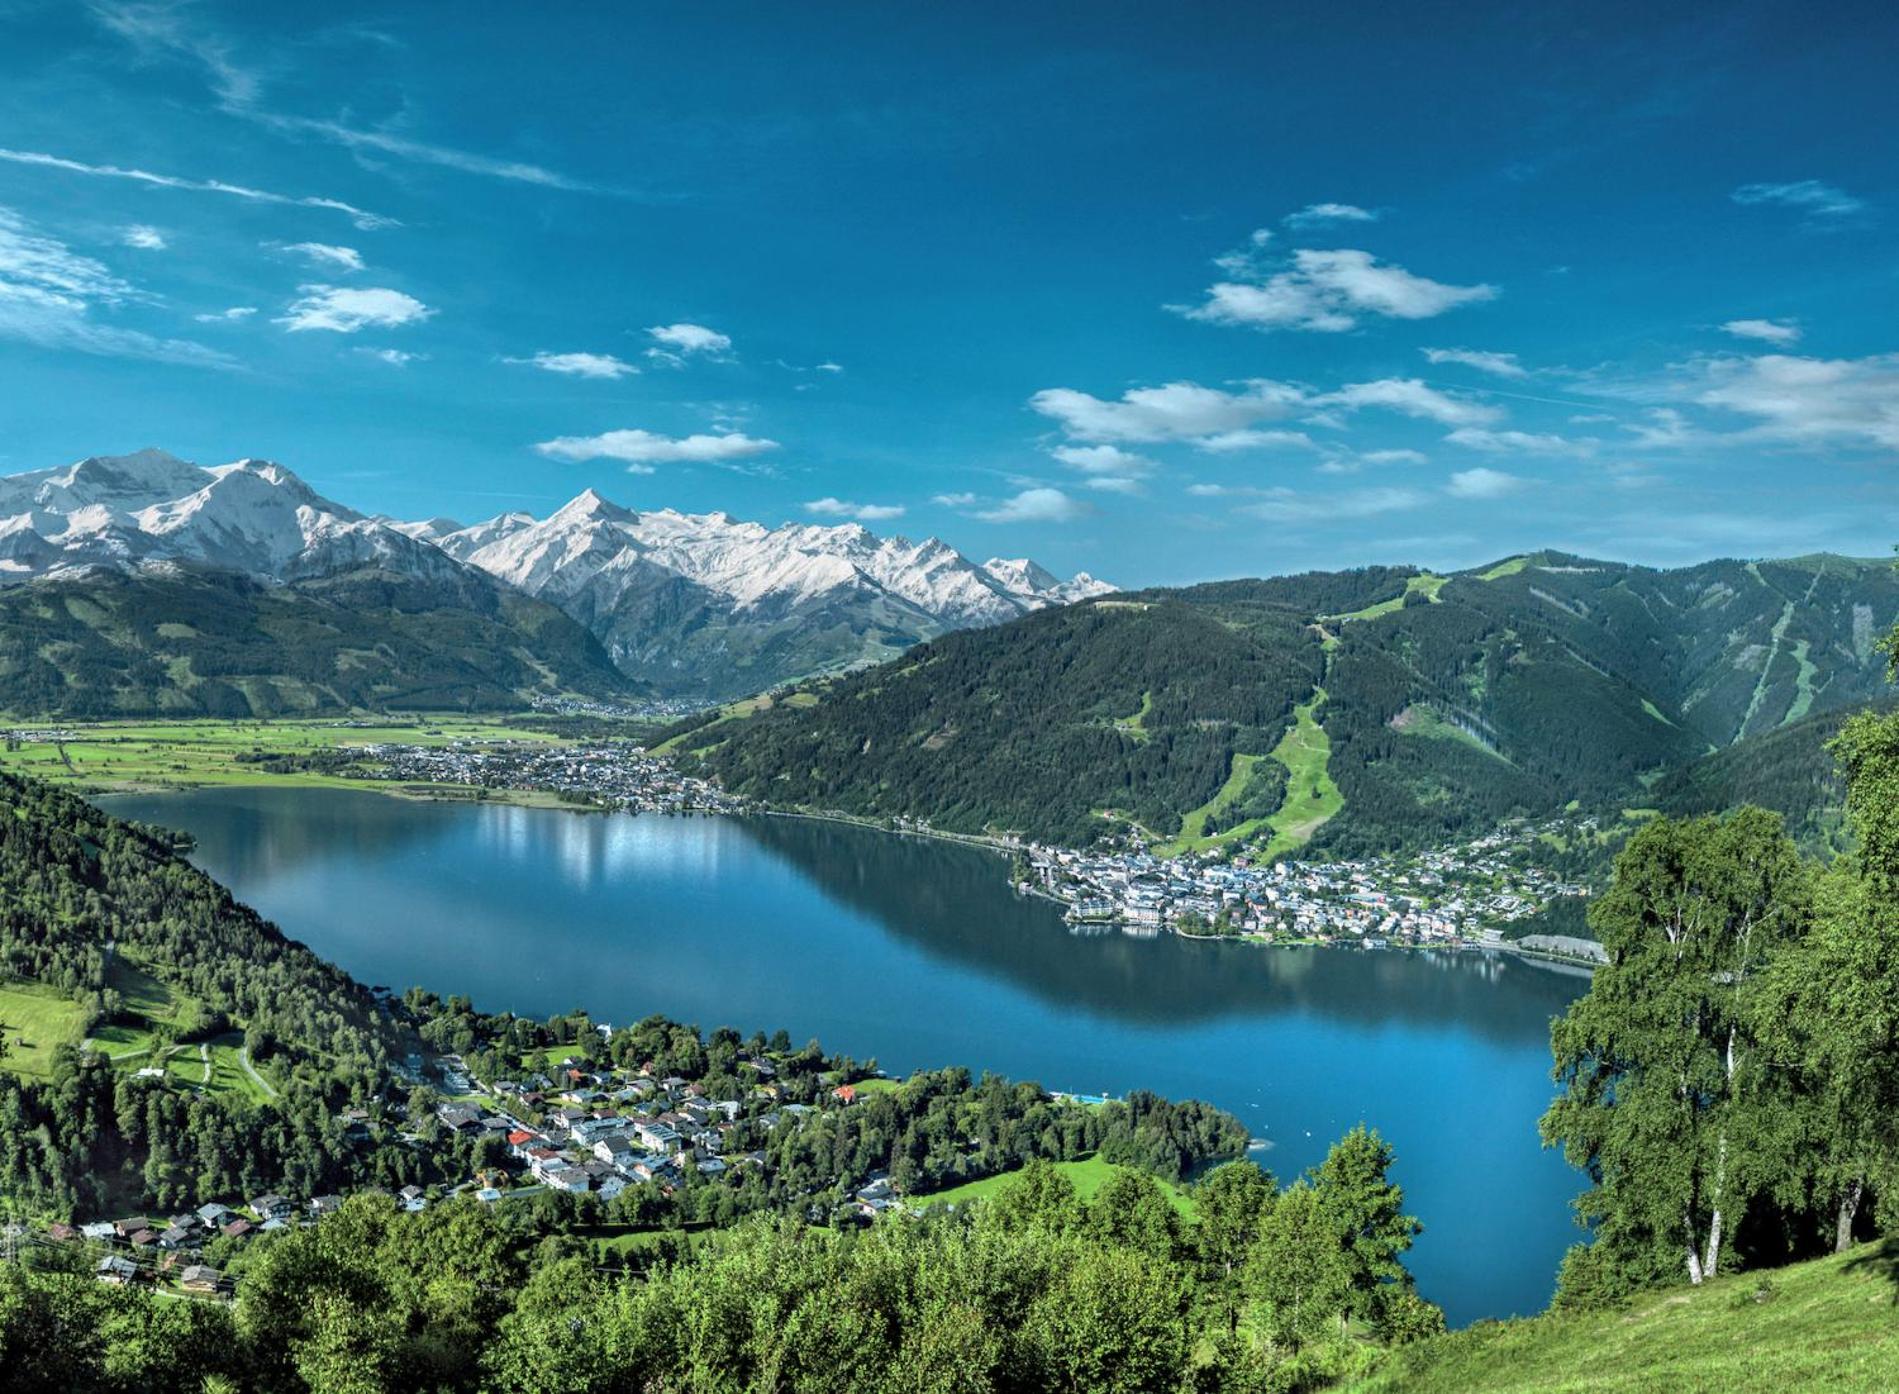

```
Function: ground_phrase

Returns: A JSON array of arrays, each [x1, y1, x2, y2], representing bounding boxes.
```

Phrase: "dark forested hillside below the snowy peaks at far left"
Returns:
[[0, 568, 640, 718]]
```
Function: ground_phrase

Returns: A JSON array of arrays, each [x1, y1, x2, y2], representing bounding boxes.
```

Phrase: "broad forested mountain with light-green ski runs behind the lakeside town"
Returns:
[[674, 555, 1899, 855]]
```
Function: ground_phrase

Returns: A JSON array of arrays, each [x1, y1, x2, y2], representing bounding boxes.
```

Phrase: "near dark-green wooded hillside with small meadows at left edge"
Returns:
[[0, 775, 406, 1214]]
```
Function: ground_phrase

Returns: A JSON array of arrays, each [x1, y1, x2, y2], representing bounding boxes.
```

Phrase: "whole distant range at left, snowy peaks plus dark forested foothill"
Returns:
[[0, 450, 1111, 714]]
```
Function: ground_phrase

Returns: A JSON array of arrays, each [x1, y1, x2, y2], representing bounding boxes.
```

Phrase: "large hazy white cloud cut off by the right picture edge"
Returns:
[[1694, 353, 1899, 450]]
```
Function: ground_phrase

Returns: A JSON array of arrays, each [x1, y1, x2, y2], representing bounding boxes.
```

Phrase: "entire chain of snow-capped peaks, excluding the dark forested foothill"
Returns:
[[0, 450, 1113, 697]]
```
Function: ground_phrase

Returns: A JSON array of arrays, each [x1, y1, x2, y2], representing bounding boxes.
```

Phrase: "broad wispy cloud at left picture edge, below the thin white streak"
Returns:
[[0, 209, 237, 368]]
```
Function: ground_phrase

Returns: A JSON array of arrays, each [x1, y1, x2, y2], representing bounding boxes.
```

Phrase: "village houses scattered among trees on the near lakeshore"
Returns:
[[0, 1018, 1120, 1301]]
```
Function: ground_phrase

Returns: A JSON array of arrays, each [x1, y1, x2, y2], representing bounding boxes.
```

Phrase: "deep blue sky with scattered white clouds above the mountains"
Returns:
[[0, 0, 1899, 583]]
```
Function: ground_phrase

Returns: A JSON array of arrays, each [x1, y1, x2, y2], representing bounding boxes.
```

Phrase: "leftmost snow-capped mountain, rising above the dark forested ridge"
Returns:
[[0, 450, 456, 581]]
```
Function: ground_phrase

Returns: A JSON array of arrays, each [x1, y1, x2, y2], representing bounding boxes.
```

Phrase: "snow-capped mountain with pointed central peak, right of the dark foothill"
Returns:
[[404, 490, 1113, 697]]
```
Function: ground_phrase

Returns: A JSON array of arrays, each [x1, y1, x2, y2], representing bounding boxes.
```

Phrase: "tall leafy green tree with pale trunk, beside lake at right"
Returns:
[[1542, 809, 1810, 1284]]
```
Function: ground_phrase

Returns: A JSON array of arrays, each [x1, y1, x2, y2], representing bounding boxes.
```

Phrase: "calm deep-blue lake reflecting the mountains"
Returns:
[[101, 788, 1588, 1324]]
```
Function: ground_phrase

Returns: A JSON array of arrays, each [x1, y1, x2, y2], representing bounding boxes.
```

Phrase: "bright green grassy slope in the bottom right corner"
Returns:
[[1348, 1242, 1899, 1394]]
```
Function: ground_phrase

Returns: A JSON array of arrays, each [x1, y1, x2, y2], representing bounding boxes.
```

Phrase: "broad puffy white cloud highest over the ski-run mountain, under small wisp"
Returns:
[[1175, 249, 1496, 334]]
